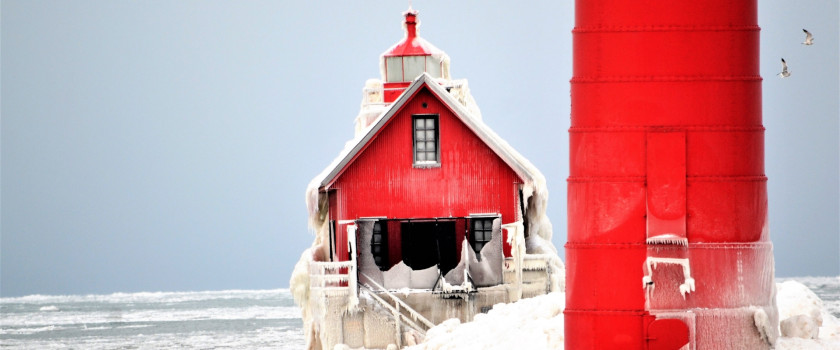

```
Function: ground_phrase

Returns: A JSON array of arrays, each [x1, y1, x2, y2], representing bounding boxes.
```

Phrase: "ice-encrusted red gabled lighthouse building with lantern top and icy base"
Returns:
[[291, 10, 563, 349]]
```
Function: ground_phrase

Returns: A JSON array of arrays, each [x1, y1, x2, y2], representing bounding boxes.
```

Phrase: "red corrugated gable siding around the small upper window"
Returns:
[[331, 88, 522, 256]]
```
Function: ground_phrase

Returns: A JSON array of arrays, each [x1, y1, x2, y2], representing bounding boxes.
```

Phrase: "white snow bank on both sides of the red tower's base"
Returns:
[[408, 281, 840, 350]]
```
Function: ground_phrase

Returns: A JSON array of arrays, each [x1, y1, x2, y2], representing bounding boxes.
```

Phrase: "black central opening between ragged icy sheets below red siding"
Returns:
[[401, 221, 458, 274]]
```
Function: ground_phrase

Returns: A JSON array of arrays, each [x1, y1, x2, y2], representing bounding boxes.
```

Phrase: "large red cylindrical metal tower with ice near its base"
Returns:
[[565, 0, 777, 350]]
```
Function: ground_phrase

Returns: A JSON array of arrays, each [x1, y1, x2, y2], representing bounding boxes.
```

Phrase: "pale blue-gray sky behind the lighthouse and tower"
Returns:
[[0, 0, 840, 296]]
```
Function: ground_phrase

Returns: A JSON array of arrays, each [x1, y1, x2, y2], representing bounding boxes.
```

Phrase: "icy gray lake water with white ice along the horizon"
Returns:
[[0, 277, 840, 349]]
